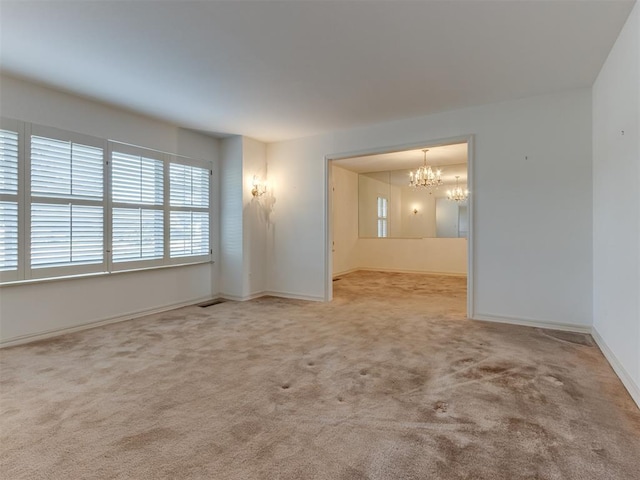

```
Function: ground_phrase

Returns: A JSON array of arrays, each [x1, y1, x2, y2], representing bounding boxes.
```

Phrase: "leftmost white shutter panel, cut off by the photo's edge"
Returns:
[[0, 129, 19, 279]]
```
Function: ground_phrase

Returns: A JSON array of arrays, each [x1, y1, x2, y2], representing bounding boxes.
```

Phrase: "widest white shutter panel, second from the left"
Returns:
[[29, 128, 105, 278]]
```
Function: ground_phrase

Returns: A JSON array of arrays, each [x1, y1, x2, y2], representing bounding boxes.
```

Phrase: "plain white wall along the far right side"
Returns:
[[593, 4, 640, 405]]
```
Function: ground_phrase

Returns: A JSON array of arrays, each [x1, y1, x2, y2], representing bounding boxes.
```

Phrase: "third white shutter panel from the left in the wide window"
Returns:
[[111, 146, 165, 269]]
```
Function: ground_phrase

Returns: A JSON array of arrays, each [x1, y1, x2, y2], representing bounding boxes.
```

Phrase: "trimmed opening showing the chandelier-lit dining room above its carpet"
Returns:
[[325, 135, 474, 318]]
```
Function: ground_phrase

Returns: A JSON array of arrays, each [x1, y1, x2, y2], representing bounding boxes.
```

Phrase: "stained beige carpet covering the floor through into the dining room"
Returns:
[[0, 272, 640, 480]]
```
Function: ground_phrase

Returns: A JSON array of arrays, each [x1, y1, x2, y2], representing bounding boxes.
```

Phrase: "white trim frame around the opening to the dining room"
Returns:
[[324, 134, 476, 318]]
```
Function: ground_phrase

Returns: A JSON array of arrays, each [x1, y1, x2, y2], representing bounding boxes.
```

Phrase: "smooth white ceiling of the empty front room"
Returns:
[[0, 0, 634, 141]]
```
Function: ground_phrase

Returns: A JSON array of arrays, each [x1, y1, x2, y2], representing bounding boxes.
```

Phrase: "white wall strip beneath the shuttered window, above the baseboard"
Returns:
[[0, 264, 211, 343]]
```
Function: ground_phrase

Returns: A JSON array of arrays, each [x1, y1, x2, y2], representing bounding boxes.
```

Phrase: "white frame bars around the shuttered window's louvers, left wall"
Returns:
[[0, 117, 214, 286]]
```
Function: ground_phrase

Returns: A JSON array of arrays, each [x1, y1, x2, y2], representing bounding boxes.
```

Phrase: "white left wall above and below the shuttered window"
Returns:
[[0, 76, 218, 342]]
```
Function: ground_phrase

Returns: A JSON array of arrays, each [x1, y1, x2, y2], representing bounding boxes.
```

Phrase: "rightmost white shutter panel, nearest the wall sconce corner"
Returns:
[[169, 163, 210, 258]]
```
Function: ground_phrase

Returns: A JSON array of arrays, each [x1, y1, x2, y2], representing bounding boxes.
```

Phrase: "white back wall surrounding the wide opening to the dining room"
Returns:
[[267, 89, 592, 328]]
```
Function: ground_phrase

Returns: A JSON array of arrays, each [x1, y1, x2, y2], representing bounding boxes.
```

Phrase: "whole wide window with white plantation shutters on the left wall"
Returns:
[[0, 119, 211, 282]]
